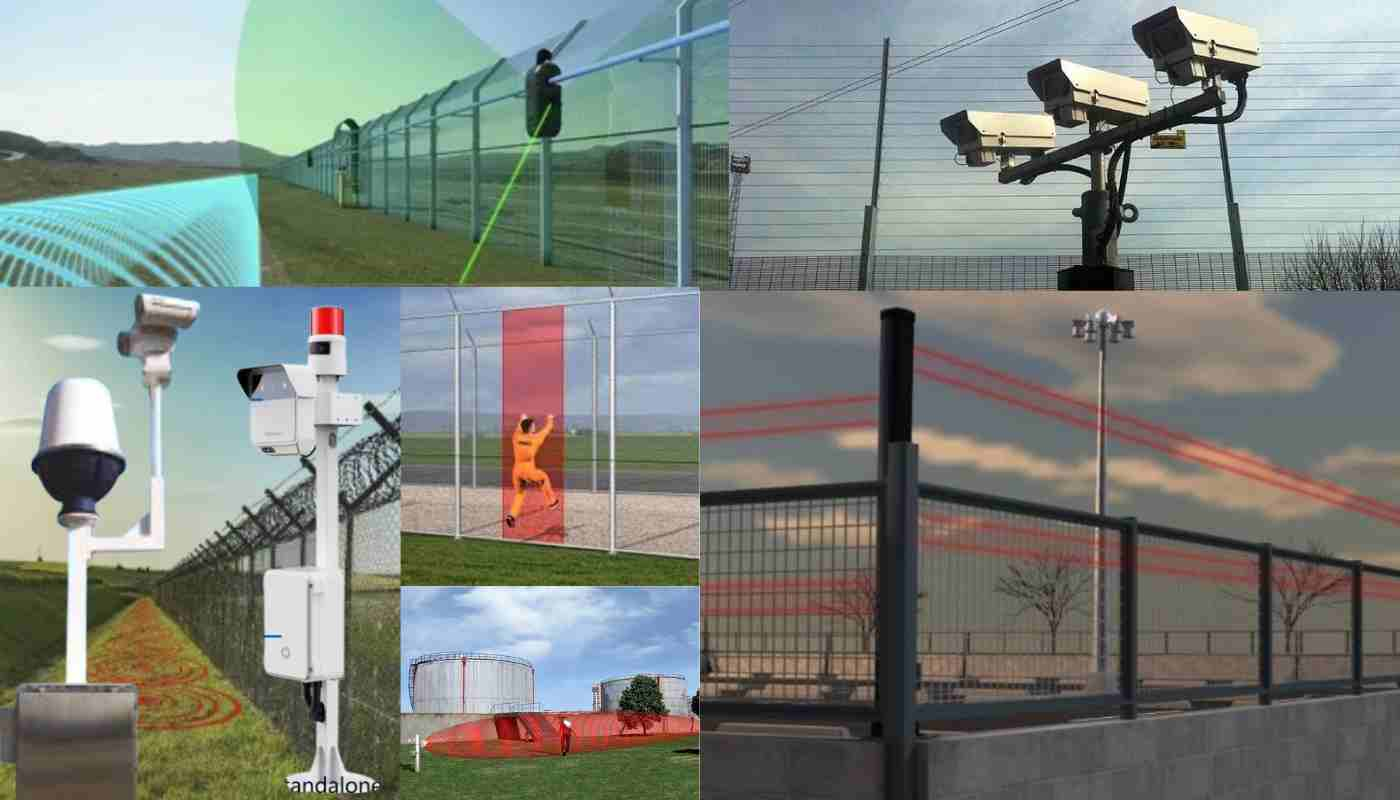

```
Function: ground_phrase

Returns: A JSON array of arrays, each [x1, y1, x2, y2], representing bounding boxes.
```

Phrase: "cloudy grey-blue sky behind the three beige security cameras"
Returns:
[[729, 0, 1400, 255]]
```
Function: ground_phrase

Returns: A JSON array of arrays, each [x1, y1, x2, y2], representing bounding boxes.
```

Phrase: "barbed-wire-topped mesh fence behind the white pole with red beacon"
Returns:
[[155, 394, 402, 792]]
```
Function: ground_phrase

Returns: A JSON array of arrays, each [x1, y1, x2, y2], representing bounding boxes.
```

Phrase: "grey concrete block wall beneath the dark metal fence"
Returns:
[[700, 692, 1400, 800]]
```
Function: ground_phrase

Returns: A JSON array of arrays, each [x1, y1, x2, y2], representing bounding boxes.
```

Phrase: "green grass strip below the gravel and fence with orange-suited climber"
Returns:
[[400, 532, 700, 586]]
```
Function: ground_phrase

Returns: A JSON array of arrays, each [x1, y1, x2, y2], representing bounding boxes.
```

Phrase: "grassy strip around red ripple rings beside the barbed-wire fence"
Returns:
[[0, 600, 347, 800]]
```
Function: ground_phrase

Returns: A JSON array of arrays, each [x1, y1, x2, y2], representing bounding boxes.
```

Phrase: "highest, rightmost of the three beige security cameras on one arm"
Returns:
[[1133, 6, 1261, 85]]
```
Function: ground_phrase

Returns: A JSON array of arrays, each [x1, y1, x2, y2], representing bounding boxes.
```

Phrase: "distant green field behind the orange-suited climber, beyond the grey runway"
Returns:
[[403, 432, 700, 469]]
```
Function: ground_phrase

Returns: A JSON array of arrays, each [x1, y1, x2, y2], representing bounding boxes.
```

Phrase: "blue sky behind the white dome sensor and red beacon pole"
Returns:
[[0, 289, 399, 567]]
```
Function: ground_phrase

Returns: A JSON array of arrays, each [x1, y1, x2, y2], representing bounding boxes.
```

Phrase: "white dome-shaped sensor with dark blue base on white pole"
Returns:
[[29, 378, 126, 528]]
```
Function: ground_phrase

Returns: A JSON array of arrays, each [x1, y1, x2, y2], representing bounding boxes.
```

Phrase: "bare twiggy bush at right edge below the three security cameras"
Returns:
[[1284, 223, 1400, 291]]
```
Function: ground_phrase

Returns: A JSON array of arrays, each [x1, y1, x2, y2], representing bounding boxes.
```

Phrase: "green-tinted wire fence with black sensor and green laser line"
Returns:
[[272, 0, 728, 284]]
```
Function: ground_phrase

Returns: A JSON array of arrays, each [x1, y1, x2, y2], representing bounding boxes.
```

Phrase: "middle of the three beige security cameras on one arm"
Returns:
[[1026, 59, 1148, 127]]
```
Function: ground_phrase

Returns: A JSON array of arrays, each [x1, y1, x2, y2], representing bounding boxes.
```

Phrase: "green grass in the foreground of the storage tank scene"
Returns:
[[399, 737, 700, 800]]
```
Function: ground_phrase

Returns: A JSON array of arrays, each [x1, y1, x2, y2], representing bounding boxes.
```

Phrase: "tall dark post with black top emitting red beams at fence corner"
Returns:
[[875, 308, 918, 800]]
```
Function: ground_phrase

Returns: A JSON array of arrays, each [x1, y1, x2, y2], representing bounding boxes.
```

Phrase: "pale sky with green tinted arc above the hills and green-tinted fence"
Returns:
[[8, 0, 722, 154]]
